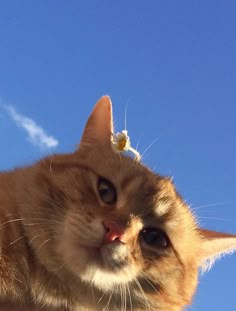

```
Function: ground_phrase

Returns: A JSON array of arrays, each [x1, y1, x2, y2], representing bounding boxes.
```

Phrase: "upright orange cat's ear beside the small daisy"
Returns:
[[79, 96, 113, 149]]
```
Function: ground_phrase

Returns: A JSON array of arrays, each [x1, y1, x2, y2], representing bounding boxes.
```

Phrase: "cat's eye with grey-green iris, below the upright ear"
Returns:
[[98, 178, 117, 204]]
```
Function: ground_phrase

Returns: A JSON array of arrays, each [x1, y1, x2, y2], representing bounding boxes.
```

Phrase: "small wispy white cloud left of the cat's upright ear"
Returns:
[[1, 104, 59, 149]]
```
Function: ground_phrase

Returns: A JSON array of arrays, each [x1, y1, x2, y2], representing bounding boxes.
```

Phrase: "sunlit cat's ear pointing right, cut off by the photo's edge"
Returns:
[[200, 229, 236, 271]]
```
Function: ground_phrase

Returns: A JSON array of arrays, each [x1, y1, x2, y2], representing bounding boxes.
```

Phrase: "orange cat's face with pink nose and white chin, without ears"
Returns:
[[28, 147, 199, 306]]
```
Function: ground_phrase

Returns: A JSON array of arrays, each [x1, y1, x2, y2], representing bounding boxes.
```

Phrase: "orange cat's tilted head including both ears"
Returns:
[[20, 96, 236, 310]]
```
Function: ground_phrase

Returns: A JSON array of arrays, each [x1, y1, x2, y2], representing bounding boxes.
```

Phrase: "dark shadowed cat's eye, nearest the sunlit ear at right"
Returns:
[[140, 228, 170, 249]]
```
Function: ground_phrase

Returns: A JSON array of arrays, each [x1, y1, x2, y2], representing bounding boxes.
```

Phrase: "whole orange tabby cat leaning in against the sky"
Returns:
[[0, 96, 236, 311]]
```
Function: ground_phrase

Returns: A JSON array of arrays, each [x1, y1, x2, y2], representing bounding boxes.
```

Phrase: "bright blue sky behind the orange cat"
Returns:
[[0, 0, 236, 311]]
